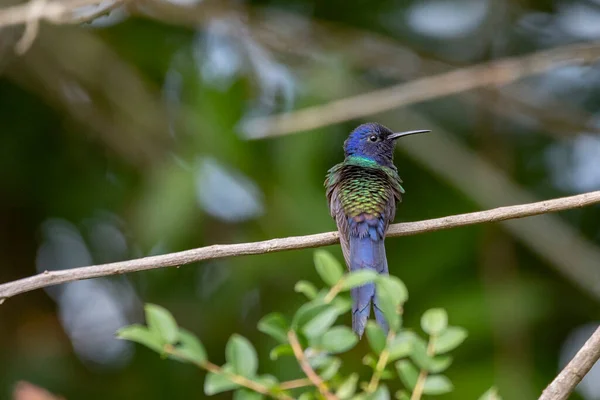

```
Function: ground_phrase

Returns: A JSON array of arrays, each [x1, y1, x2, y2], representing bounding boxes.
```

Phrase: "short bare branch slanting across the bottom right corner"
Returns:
[[539, 327, 600, 400]]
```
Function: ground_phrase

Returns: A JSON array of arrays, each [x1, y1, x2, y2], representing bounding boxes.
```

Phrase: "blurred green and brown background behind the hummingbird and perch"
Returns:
[[0, 0, 600, 400]]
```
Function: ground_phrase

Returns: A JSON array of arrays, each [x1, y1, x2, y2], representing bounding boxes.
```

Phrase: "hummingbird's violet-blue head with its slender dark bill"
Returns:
[[344, 122, 429, 166]]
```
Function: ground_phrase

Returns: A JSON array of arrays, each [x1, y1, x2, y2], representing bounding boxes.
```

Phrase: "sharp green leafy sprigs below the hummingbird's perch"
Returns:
[[117, 250, 488, 400]]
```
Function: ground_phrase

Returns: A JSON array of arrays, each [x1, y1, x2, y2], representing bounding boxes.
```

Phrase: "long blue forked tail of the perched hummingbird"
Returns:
[[350, 234, 388, 337]]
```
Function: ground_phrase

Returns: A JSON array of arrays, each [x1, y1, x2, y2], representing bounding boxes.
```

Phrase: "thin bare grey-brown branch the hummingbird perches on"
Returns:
[[0, 191, 600, 300]]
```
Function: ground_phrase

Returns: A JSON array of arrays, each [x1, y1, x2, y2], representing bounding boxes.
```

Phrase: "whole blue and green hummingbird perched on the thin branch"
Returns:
[[325, 122, 430, 337]]
